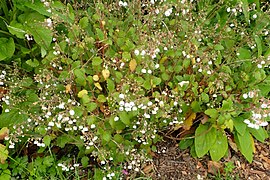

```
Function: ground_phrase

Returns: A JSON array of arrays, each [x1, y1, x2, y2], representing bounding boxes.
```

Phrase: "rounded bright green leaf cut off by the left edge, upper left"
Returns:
[[0, 38, 15, 61]]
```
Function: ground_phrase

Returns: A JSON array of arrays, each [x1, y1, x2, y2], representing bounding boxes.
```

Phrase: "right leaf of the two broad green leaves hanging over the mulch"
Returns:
[[209, 131, 228, 161]]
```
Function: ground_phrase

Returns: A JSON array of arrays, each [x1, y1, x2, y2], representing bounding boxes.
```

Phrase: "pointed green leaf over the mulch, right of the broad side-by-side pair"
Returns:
[[235, 131, 254, 163]]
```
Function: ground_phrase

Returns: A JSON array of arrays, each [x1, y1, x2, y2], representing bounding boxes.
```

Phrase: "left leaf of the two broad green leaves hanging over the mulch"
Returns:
[[195, 124, 217, 157]]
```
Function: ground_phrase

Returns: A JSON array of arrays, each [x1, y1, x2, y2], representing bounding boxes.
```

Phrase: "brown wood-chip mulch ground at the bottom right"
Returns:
[[149, 139, 270, 180]]
